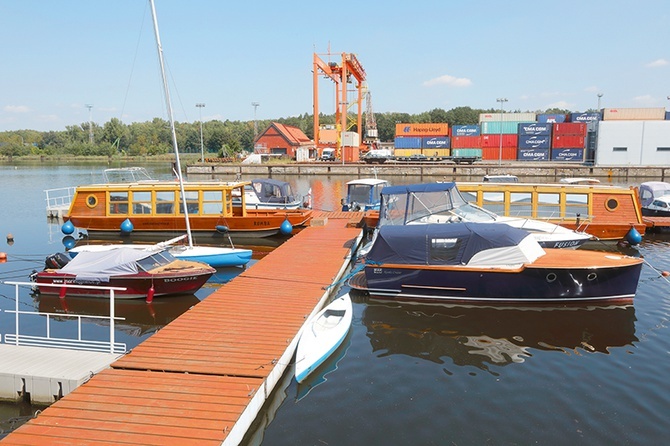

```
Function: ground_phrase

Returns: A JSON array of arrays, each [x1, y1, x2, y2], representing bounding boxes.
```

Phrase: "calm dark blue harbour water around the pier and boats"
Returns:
[[0, 166, 670, 446]]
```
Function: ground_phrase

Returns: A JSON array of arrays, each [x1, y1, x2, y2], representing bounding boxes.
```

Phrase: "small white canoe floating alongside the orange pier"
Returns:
[[295, 294, 353, 383]]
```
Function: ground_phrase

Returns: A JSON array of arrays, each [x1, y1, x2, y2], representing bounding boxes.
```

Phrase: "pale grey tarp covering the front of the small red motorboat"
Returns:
[[61, 248, 153, 282]]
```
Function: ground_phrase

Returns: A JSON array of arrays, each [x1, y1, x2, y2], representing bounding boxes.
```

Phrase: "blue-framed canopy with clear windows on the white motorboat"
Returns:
[[379, 182, 468, 226]]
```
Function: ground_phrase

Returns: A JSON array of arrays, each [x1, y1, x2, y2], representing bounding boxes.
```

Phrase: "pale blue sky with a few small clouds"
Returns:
[[0, 0, 670, 131]]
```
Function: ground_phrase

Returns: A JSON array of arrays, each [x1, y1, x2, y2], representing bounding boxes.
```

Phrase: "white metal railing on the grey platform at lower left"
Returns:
[[3, 282, 127, 354]]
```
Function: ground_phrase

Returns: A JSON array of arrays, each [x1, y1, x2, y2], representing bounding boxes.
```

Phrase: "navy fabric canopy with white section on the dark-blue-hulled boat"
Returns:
[[366, 223, 545, 267]]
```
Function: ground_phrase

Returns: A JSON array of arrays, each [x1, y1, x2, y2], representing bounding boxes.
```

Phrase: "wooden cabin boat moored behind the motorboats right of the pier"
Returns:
[[457, 182, 646, 244]]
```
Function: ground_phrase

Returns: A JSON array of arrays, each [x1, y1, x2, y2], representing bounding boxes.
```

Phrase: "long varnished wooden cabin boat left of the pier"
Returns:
[[62, 180, 312, 238]]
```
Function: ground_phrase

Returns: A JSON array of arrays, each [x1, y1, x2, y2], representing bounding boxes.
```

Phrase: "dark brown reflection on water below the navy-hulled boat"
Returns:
[[362, 300, 637, 369]]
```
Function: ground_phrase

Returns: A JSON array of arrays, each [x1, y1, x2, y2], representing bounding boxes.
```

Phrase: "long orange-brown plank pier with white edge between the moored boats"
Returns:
[[2, 212, 363, 446]]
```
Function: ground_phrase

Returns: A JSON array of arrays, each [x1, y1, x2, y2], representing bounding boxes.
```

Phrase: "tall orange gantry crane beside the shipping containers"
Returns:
[[313, 53, 365, 157]]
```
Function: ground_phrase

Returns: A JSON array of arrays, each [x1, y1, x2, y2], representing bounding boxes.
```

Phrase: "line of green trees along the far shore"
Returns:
[[0, 107, 569, 158]]
